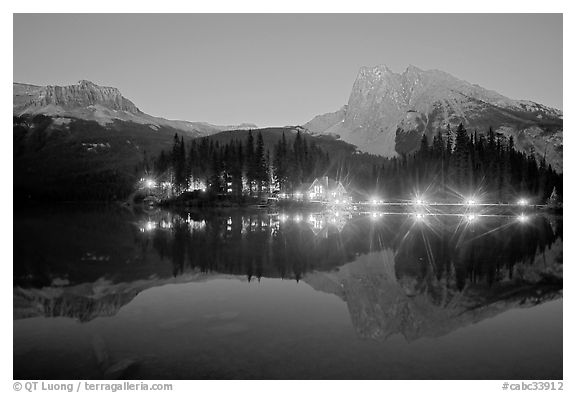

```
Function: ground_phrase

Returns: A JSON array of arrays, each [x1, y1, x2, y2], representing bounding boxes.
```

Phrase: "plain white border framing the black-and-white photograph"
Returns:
[[0, 0, 576, 393]]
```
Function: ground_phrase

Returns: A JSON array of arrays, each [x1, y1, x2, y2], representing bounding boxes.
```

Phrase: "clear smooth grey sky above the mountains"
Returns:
[[13, 14, 563, 127]]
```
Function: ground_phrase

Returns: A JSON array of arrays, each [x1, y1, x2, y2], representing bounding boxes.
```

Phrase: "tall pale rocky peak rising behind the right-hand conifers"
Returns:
[[304, 65, 563, 171]]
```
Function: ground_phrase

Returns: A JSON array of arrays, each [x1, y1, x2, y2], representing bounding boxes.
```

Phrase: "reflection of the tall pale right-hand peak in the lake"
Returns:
[[303, 241, 563, 341]]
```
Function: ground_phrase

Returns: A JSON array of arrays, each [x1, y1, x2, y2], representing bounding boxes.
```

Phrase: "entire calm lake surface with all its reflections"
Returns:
[[14, 206, 562, 379]]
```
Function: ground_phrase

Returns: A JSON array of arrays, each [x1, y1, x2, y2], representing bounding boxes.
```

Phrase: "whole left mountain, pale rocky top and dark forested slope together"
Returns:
[[13, 81, 255, 201]]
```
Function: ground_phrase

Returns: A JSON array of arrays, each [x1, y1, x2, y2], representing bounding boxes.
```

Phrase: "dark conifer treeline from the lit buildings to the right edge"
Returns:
[[146, 125, 562, 203]]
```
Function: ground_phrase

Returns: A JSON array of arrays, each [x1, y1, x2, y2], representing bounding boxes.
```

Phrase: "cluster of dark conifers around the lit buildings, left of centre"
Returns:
[[151, 131, 330, 198]]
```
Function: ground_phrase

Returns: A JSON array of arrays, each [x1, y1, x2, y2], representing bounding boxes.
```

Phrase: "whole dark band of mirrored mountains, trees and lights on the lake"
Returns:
[[14, 208, 562, 340]]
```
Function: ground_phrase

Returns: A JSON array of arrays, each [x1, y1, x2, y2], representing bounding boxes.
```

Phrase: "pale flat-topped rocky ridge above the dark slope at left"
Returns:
[[13, 80, 257, 136]]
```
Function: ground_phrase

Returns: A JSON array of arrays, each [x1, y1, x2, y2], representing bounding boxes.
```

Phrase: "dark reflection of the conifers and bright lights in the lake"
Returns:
[[137, 212, 561, 290]]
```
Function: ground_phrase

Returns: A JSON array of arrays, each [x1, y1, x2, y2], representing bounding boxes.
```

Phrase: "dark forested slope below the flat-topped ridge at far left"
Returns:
[[13, 115, 154, 204]]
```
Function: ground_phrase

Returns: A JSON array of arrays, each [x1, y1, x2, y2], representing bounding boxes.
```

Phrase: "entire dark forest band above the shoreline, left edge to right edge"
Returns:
[[13, 115, 563, 204]]
